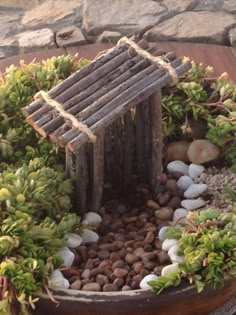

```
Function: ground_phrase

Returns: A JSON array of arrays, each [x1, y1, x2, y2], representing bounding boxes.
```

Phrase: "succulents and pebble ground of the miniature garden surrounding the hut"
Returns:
[[0, 40, 236, 315]]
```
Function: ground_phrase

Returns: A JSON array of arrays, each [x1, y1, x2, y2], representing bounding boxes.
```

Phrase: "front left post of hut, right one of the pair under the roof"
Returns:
[[91, 133, 104, 212]]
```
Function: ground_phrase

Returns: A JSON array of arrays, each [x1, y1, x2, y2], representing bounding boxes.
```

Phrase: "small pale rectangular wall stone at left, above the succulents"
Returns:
[[17, 28, 55, 52]]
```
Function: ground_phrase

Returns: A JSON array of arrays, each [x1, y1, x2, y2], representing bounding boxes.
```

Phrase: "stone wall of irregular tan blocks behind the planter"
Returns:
[[0, 0, 236, 58]]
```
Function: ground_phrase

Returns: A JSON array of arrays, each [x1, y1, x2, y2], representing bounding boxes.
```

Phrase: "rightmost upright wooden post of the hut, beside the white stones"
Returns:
[[150, 89, 162, 192]]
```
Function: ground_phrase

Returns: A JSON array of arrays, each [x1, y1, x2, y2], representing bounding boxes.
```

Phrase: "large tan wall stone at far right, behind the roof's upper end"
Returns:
[[145, 11, 236, 44]]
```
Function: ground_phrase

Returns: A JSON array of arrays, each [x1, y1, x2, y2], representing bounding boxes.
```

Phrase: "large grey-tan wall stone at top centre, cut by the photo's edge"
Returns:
[[83, 0, 168, 36]]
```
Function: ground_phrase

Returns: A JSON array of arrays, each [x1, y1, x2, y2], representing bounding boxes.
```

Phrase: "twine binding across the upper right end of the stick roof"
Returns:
[[117, 36, 179, 85]]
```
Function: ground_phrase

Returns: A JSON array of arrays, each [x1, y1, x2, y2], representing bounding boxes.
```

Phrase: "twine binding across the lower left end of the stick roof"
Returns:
[[34, 91, 96, 142]]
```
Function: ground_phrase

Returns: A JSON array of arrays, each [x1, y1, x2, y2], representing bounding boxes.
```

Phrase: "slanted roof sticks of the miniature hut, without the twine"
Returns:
[[23, 40, 191, 152]]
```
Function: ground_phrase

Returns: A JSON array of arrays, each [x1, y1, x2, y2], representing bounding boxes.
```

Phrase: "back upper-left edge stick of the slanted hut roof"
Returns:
[[23, 45, 128, 116]]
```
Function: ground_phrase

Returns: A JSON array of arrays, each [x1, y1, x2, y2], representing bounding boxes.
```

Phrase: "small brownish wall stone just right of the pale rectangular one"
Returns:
[[56, 26, 86, 47]]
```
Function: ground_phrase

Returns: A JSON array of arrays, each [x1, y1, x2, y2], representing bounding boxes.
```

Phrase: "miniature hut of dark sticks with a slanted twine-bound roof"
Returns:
[[23, 39, 191, 212]]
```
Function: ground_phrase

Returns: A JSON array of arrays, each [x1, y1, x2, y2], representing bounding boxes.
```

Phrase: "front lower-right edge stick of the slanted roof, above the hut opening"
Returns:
[[67, 62, 191, 152]]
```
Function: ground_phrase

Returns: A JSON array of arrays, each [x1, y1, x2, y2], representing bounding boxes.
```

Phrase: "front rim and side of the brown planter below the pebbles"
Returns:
[[33, 280, 236, 315]]
